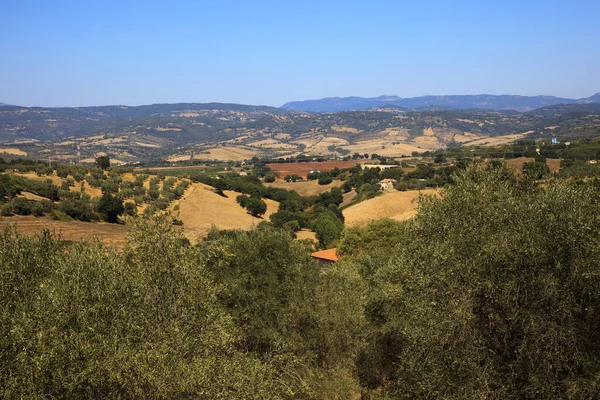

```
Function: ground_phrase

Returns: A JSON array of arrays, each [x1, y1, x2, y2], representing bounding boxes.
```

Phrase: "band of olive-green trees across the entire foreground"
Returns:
[[0, 163, 600, 399]]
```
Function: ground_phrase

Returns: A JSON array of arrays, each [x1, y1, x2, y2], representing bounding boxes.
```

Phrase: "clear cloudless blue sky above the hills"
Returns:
[[0, 0, 600, 106]]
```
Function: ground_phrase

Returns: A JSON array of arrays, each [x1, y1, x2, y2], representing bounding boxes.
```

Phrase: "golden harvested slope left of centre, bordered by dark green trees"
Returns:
[[171, 183, 279, 241]]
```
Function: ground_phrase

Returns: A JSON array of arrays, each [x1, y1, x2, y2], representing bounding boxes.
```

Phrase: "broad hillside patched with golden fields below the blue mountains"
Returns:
[[0, 100, 600, 164]]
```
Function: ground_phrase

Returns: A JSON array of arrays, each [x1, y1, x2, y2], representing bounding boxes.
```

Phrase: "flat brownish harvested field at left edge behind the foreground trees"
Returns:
[[0, 215, 128, 245]]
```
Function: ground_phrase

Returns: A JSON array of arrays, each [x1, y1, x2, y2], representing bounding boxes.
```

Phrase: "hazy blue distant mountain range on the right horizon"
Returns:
[[281, 93, 600, 112]]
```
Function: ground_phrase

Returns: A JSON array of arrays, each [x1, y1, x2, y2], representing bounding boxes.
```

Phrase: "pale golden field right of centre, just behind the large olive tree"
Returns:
[[343, 189, 437, 227]]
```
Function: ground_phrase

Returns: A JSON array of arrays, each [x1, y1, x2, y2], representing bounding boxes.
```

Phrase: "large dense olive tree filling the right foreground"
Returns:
[[357, 164, 600, 399]]
